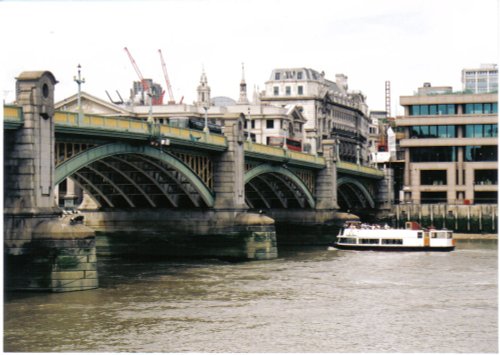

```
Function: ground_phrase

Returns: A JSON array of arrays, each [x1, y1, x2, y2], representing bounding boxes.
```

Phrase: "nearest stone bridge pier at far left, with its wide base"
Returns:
[[4, 71, 97, 292]]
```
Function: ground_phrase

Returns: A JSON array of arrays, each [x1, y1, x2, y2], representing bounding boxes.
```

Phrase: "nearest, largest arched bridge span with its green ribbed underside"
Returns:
[[55, 143, 214, 208]]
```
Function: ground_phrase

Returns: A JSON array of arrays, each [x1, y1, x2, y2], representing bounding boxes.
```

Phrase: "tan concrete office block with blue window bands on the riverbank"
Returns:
[[396, 83, 498, 205]]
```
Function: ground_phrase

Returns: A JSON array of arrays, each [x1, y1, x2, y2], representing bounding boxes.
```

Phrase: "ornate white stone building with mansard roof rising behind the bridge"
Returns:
[[260, 68, 370, 164]]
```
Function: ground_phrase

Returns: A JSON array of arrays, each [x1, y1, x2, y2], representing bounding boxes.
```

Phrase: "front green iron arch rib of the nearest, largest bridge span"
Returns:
[[55, 143, 214, 207]]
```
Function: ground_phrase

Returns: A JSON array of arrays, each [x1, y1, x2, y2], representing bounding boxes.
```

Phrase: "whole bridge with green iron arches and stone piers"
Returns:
[[4, 72, 384, 290]]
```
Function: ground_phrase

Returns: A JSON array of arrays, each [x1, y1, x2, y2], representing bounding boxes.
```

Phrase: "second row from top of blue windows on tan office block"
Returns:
[[410, 124, 498, 138]]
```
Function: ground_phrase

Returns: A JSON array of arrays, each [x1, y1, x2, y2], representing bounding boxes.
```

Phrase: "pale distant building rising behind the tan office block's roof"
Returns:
[[462, 64, 498, 94]]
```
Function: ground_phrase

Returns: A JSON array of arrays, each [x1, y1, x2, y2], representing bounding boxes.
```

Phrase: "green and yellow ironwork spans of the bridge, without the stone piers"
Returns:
[[4, 106, 384, 212]]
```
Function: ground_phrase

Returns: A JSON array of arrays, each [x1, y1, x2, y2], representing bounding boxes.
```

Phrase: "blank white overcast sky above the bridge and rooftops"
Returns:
[[0, 0, 499, 114]]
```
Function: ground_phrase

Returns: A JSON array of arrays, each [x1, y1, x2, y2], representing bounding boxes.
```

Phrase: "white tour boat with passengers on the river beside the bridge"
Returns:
[[333, 222, 455, 251]]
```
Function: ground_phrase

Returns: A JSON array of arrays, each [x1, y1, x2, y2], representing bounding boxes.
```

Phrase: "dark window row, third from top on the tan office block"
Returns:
[[410, 146, 498, 163]]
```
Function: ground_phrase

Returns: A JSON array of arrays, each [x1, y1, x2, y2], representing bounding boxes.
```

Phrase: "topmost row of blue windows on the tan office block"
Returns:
[[410, 102, 498, 116]]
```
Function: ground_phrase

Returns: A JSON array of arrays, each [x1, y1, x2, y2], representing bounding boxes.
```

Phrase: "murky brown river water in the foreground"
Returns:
[[4, 241, 498, 353]]
